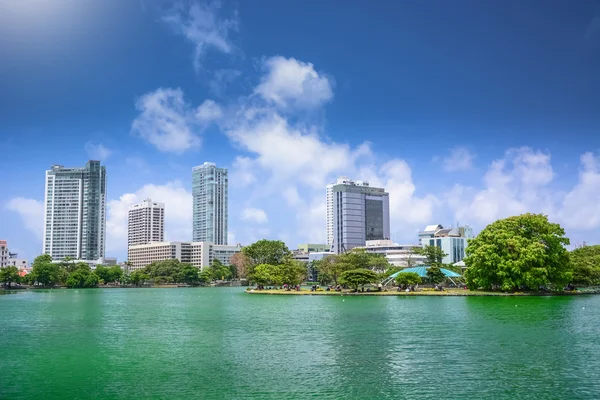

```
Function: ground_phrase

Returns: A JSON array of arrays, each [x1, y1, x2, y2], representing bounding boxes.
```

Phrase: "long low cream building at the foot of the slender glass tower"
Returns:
[[129, 242, 242, 271]]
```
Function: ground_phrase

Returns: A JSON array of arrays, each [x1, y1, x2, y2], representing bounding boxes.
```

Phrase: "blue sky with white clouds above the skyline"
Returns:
[[0, 0, 600, 261]]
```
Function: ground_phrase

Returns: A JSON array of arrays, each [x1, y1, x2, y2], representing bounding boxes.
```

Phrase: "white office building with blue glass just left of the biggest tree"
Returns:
[[419, 225, 473, 264]]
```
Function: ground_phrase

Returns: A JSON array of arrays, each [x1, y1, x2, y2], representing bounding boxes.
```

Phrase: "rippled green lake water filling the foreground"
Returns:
[[0, 288, 600, 399]]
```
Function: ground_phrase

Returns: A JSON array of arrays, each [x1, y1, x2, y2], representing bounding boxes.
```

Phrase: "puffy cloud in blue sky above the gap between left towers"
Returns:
[[131, 88, 201, 153]]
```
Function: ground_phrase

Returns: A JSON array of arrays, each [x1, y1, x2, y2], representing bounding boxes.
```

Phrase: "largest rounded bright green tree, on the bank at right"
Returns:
[[464, 214, 572, 291]]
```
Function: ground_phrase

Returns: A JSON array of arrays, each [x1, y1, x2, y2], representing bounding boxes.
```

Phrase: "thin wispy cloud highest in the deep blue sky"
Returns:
[[163, 2, 238, 72]]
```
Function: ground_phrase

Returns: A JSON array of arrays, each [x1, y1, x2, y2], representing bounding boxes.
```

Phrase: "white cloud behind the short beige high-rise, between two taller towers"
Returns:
[[106, 181, 192, 255]]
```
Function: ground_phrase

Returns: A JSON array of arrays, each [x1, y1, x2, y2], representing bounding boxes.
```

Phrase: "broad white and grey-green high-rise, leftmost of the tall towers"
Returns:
[[43, 161, 106, 260]]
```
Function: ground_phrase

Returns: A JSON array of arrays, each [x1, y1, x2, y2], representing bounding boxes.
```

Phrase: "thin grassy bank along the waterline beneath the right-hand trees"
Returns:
[[245, 289, 590, 296]]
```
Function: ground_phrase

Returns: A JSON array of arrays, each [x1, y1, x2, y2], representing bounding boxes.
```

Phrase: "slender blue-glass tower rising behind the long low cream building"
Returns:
[[192, 162, 228, 244]]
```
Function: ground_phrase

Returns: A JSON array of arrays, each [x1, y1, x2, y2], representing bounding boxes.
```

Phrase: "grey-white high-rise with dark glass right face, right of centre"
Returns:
[[327, 177, 390, 254]]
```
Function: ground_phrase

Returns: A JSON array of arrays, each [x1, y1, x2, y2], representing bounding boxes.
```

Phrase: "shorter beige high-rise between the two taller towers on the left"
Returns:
[[127, 199, 165, 252]]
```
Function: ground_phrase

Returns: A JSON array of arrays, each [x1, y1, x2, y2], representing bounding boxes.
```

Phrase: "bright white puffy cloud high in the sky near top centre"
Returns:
[[255, 56, 333, 108]]
